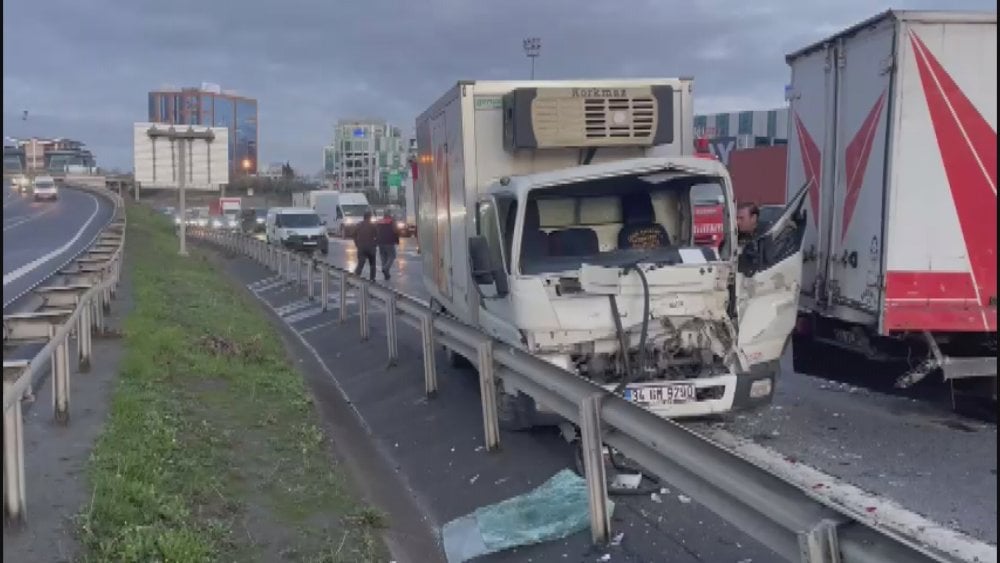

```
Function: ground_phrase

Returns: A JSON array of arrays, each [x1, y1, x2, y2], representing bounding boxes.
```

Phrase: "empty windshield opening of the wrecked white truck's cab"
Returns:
[[501, 171, 726, 275]]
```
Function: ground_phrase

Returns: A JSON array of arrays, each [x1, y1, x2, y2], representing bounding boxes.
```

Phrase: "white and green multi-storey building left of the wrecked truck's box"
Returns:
[[323, 119, 410, 198]]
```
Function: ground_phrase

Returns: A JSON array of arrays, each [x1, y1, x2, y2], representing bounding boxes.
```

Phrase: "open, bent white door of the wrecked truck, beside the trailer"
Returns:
[[736, 183, 809, 370]]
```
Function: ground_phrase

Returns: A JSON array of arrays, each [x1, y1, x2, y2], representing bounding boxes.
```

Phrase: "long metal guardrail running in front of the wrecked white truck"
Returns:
[[192, 229, 996, 563]]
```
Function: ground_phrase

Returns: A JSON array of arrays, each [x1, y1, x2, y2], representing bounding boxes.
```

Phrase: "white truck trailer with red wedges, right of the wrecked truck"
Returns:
[[787, 12, 997, 400]]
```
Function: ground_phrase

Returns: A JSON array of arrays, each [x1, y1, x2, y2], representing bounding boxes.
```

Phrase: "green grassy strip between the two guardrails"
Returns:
[[79, 206, 386, 563]]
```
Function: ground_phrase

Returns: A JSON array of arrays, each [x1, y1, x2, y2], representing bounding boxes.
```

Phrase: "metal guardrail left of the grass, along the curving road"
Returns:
[[3, 187, 125, 523]]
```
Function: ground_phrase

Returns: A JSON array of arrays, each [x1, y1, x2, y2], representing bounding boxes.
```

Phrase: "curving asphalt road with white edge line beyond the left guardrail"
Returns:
[[3, 184, 113, 312]]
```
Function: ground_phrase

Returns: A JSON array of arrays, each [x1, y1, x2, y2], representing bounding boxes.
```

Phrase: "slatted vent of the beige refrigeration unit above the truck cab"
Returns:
[[583, 96, 656, 139]]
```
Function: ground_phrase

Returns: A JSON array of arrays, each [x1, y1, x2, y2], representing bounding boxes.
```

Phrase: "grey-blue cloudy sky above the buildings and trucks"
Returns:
[[3, 0, 996, 173]]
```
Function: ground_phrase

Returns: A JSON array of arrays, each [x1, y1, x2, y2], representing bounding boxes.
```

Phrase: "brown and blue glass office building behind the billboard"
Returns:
[[149, 83, 260, 178]]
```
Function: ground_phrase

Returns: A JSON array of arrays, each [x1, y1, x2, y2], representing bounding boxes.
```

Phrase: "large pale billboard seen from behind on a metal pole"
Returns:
[[133, 123, 229, 190]]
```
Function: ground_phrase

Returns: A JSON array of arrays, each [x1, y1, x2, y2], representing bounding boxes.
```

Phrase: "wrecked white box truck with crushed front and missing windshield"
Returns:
[[416, 79, 805, 428]]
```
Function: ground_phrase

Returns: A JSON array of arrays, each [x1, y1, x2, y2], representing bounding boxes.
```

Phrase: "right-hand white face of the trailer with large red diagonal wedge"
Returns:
[[879, 14, 997, 333]]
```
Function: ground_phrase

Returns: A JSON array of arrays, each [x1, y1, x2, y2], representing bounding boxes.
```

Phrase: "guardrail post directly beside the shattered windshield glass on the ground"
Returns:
[[580, 393, 611, 544]]
